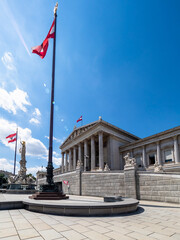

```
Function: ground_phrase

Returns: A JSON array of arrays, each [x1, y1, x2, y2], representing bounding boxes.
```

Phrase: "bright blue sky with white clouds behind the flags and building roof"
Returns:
[[0, 0, 180, 174]]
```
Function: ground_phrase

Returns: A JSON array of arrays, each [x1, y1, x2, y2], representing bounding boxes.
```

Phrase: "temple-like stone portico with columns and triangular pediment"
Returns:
[[60, 117, 140, 173]]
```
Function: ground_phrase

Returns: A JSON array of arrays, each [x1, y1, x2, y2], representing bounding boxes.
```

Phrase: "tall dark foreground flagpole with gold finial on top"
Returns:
[[46, 3, 58, 190]]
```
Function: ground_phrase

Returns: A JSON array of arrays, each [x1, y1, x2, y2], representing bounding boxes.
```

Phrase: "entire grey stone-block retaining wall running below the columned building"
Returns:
[[36, 169, 180, 203]]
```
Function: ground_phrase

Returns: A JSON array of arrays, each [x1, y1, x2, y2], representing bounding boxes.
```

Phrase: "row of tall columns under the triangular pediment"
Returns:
[[61, 132, 104, 173]]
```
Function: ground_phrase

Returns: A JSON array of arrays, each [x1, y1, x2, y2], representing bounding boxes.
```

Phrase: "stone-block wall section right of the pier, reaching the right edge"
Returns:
[[137, 173, 180, 203]]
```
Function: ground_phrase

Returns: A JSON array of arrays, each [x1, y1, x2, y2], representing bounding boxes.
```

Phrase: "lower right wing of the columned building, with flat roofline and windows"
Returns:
[[119, 127, 180, 172]]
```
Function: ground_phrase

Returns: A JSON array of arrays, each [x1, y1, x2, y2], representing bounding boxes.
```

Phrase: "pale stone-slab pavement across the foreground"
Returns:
[[0, 201, 180, 240]]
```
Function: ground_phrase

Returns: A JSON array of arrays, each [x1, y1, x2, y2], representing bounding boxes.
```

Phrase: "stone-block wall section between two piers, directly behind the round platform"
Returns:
[[82, 172, 125, 197]]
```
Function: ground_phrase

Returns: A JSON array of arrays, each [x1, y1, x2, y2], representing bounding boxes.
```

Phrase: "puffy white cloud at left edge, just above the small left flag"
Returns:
[[0, 88, 31, 114]]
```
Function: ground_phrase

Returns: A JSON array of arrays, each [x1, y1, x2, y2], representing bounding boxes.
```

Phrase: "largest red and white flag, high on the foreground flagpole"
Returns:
[[31, 19, 55, 59]]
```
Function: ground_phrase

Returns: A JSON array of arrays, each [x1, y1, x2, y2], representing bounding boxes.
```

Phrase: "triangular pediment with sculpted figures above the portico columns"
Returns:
[[61, 121, 98, 147]]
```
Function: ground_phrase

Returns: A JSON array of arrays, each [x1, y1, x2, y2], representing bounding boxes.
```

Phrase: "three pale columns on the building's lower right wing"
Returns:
[[142, 136, 180, 167]]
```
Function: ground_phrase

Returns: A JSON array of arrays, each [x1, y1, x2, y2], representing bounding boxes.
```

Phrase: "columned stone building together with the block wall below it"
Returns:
[[36, 117, 180, 203]]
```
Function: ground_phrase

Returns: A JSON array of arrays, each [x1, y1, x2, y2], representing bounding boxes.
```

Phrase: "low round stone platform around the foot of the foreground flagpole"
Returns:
[[23, 196, 139, 216]]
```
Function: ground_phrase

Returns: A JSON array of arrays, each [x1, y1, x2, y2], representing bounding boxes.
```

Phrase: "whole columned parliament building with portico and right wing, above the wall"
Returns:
[[60, 117, 180, 173]]
